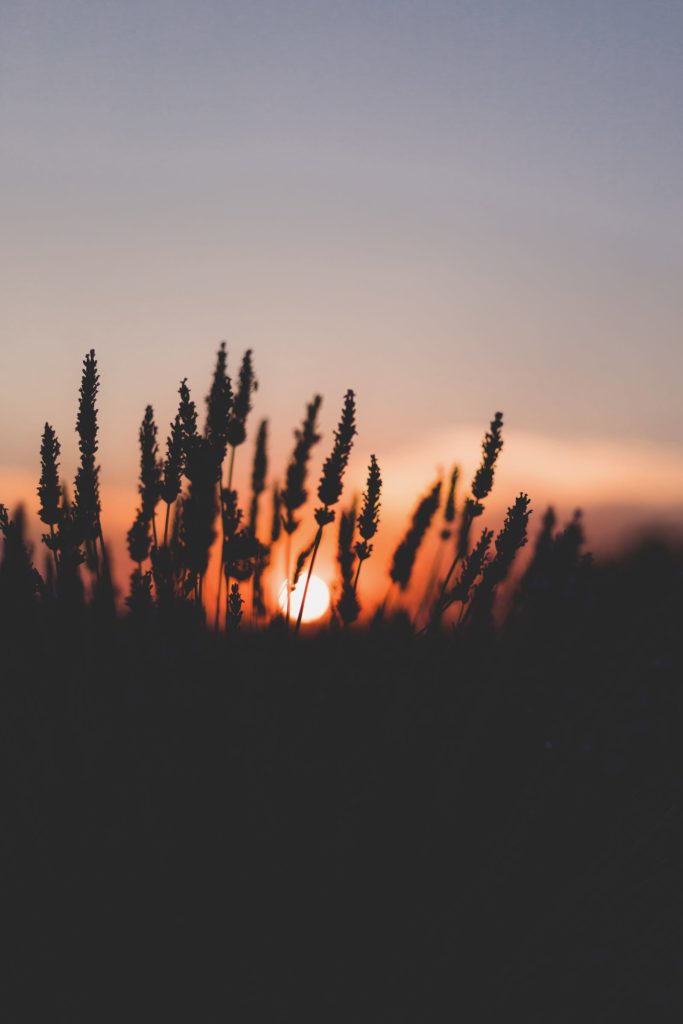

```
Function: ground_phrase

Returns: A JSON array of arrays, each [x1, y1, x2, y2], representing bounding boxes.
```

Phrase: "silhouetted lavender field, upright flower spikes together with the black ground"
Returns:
[[0, 346, 683, 1024]]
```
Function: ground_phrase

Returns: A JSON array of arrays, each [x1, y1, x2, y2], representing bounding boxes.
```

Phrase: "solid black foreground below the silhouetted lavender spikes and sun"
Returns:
[[0, 546, 683, 1024]]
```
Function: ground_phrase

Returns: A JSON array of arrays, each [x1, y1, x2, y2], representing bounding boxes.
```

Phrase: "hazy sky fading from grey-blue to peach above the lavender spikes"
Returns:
[[0, 0, 683, 598]]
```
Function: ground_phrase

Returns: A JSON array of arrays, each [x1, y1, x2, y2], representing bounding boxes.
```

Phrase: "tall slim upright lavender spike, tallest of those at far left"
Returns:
[[74, 349, 100, 541]]
